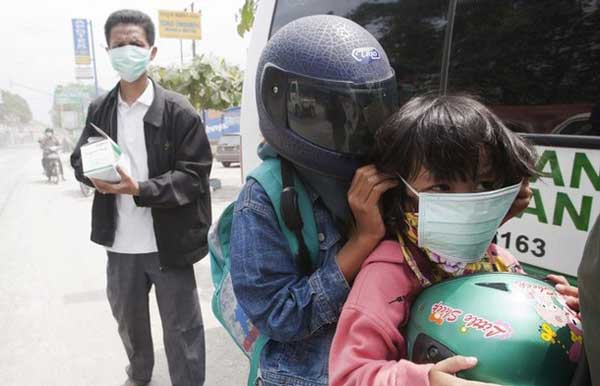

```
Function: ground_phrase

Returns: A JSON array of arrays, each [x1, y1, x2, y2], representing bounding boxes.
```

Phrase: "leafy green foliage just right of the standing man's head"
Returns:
[[150, 55, 243, 110]]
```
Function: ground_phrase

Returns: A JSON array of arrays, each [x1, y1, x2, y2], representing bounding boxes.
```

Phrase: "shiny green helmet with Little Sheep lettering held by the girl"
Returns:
[[406, 273, 583, 386]]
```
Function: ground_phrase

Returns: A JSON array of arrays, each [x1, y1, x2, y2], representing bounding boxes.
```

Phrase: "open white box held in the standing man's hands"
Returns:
[[81, 123, 121, 182]]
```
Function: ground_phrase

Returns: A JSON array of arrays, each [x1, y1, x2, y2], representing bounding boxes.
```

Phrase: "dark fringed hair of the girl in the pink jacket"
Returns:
[[371, 94, 537, 237]]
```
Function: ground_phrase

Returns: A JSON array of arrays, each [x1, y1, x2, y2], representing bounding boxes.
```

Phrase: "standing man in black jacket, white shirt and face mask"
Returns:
[[71, 10, 212, 386]]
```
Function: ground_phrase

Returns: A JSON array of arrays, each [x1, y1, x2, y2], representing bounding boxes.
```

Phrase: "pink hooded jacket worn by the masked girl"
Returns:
[[329, 241, 518, 386]]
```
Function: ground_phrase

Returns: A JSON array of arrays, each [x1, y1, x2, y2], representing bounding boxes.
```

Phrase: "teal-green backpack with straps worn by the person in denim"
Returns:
[[208, 158, 320, 386]]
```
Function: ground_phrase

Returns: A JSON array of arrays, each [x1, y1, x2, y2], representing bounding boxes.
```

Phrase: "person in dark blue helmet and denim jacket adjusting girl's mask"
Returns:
[[229, 15, 529, 386]]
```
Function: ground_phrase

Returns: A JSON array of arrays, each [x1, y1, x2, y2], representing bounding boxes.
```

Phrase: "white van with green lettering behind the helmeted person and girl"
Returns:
[[241, 0, 600, 277]]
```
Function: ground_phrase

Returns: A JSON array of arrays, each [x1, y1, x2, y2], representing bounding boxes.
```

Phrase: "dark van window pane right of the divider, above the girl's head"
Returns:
[[448, 0, 600, 135]]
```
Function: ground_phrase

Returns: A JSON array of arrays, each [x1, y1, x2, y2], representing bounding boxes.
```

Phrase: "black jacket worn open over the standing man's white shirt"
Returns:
[[71, 82, 212, 267]]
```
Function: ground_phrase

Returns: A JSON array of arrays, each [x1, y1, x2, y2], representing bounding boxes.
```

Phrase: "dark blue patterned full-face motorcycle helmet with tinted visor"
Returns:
[[256, 15, 398, 181]]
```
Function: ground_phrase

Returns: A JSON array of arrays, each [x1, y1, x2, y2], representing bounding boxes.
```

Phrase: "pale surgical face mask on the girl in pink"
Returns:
[[400, 177, 521, 263]]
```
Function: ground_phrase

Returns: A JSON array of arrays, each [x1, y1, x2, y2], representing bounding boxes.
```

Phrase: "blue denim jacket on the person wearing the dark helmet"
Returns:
[[230, 179, 350, 386]]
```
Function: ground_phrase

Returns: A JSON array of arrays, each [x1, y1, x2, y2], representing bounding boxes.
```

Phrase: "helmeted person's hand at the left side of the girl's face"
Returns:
[[348, 165, 398, 247]]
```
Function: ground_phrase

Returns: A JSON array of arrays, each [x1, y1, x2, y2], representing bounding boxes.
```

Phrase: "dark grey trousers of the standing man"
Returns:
[[106, 252, 205, 386]]
